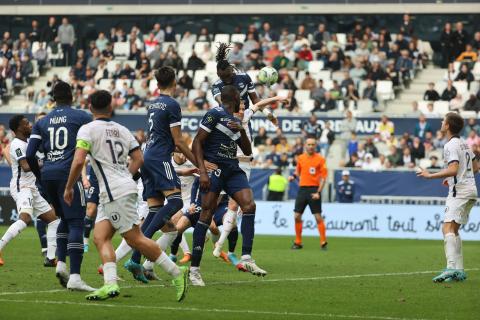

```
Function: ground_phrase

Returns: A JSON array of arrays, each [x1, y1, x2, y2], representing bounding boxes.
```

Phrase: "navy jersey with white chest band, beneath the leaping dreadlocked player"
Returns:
[[200, 106, 241, 166]]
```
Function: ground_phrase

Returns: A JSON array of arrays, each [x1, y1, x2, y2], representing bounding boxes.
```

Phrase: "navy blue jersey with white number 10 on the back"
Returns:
[[27, 106, 92, 180]]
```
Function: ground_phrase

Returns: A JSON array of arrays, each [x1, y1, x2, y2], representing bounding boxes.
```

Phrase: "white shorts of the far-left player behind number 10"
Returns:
[[11, 188, 52, 218]]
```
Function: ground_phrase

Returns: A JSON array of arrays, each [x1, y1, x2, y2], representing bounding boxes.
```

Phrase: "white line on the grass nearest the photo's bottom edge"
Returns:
[[0, 299, 427, 320]]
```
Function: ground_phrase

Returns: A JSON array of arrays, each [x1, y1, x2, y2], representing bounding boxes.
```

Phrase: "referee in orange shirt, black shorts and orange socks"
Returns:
[[289, 138, 327, 250]]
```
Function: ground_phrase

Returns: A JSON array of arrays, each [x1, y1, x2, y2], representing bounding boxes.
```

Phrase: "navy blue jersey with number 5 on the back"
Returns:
[[145, 95, 182, 161]]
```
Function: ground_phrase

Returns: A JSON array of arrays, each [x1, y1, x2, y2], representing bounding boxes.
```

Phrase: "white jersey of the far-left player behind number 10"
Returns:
[[10, 138, 37, 192]]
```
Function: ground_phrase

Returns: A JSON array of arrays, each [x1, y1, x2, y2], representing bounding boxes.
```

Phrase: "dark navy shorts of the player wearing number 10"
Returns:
[[42, 180, 86, 219]]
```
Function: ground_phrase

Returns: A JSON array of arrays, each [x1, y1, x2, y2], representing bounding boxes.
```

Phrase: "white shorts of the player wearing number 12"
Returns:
[[95, 193, 140, 234]]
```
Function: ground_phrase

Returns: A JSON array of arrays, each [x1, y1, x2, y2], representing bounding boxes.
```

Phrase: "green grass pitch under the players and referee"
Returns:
[[0, 227, 480, 320]]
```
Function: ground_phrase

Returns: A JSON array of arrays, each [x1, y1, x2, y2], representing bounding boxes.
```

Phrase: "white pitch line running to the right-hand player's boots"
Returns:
[[0, 268, 480, 296]]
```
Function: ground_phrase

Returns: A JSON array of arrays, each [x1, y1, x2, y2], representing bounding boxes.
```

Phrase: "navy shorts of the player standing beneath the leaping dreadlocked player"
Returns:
[[209, 165, 250, 197]]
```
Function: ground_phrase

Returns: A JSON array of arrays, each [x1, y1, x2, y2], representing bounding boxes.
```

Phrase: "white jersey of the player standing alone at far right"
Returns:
[[443, 137, 477, 199]]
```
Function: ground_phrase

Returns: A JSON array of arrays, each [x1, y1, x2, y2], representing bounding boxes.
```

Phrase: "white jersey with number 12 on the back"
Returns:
[[77, 119, 140, 204]]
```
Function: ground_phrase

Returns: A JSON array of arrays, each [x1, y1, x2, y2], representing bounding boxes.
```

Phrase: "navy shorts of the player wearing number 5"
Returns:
[[141, 158, 181, 199]]
